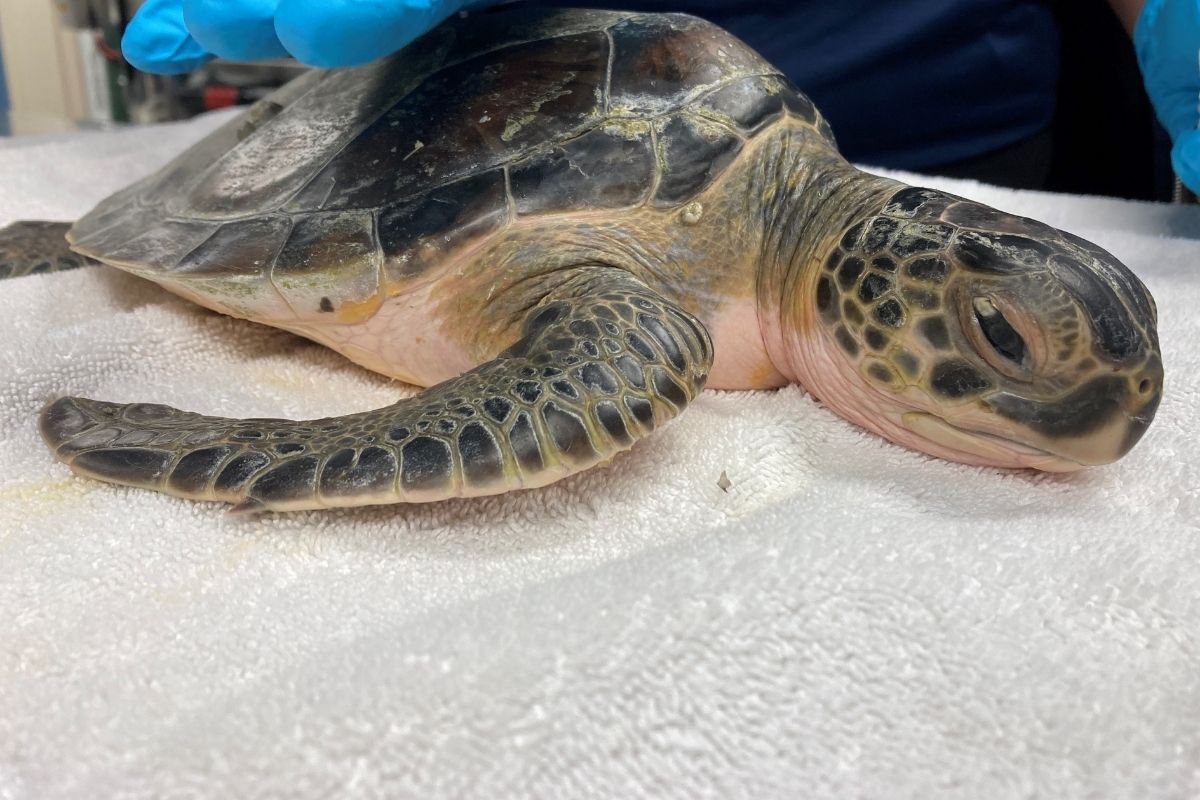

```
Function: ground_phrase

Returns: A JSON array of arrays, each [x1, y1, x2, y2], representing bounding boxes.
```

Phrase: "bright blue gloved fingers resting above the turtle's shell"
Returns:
[[121, 0, 488, 74]]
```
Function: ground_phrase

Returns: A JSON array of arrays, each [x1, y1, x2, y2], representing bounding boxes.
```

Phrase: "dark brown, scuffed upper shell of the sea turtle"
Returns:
[[65, 8, 832, 321]]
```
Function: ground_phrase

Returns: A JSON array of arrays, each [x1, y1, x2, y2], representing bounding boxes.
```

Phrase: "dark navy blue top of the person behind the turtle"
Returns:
[[525, 0, 1058, 170]]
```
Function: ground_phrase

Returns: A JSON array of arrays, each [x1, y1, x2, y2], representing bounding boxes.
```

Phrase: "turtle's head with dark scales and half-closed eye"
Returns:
[[802, 187, 1163, 471]]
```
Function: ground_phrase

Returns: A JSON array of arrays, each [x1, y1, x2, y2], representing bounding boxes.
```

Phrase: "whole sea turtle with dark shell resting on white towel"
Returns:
[[0, 8, 1163, 510]]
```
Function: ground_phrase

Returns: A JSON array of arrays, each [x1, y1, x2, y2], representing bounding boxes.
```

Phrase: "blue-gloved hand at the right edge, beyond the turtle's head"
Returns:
[[1133, 0, 1200, 193]]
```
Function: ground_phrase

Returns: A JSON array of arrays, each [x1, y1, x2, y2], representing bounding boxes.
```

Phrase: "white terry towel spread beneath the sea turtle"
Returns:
[[0, 109, 1200, 799]]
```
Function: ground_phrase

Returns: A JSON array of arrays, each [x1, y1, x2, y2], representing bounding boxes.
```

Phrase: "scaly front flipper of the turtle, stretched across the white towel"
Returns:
[[41, 270, 713, 511]]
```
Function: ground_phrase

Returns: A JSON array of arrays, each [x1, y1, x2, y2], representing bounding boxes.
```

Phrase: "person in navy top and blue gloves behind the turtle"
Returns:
[[122, 0, 1200, 192]]
